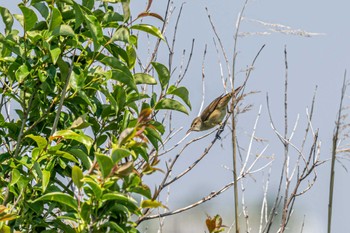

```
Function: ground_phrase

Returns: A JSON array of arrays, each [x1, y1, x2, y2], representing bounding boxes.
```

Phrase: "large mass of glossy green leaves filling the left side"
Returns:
[[0, 0, 191, 232]]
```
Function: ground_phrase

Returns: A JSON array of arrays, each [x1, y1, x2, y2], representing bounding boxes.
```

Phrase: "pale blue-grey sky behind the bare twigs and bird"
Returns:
[[0, 0, 350, 233]]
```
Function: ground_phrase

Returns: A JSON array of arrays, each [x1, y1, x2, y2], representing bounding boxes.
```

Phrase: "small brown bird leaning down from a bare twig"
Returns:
[[187, 86, 242, 133]]
